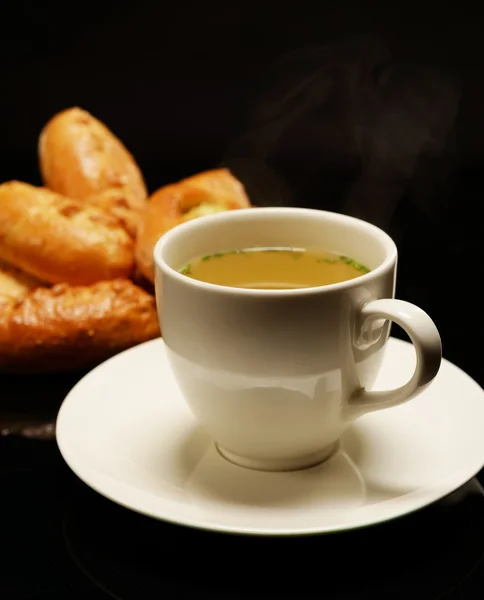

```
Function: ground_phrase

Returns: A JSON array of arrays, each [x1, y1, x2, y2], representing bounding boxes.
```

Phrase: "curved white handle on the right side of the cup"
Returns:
[[347, 298, 442, 419]]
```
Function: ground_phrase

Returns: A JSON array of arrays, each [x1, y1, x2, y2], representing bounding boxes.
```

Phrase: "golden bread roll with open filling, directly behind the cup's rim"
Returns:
[[135, 169, 251, 281]]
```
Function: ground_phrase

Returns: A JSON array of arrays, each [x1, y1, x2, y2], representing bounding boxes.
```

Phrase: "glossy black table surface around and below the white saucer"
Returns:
[[0, 342, 484, 600]]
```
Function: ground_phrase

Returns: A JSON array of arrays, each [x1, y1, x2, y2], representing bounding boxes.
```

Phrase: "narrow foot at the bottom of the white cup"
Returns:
[[215, 441, 339, 471]]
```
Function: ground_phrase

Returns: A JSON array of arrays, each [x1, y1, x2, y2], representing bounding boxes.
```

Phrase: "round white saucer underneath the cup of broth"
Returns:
[[57, 339, 484, 535]]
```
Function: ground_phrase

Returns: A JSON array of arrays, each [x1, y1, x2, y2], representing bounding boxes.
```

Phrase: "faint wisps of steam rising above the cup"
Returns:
[[225, 37, 460, 228]]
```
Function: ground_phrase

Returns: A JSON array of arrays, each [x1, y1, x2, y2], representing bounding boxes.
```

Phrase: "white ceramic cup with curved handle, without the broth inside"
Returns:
[[154, 208, 442, 471]]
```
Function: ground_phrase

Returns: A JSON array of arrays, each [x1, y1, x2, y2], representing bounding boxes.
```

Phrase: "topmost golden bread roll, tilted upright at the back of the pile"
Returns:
[[38, 108, 147, 229]]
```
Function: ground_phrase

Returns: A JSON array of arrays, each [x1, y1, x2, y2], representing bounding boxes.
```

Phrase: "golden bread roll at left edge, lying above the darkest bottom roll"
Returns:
[[0, 181, 134, 285]]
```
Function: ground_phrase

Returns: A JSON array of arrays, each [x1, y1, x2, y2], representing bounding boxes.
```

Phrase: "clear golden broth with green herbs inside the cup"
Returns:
[[180, 247, 369, 290]]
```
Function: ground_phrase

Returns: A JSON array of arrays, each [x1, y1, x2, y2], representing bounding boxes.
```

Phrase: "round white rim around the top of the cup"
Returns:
[[153, 206, 398, 298]]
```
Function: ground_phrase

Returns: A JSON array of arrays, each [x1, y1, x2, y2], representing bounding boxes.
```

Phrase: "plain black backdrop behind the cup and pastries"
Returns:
[[0, 0, 484, 383]]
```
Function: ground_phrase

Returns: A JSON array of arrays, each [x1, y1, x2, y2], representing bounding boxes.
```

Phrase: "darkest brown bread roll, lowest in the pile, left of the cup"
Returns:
[[0, 280, 159, 373]]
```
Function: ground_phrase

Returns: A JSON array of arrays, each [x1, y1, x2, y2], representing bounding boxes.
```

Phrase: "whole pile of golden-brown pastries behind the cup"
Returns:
[[0, 108, 250, 373]]
